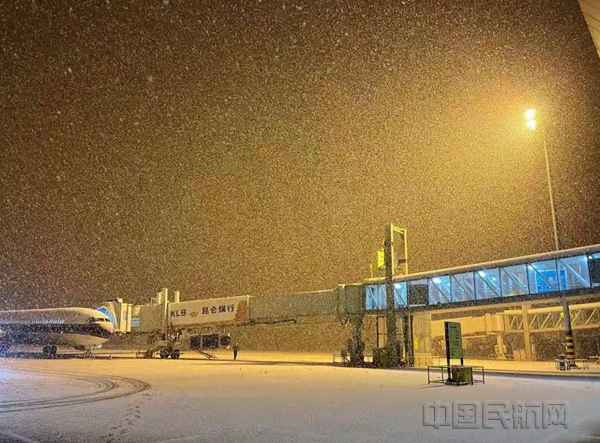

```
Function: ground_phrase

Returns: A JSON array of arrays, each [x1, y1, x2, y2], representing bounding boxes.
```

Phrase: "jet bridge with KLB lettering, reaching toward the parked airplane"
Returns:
[[98, 284, 365, 358]]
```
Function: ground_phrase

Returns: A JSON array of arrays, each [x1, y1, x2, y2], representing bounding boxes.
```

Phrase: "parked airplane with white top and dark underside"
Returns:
[[0, 308, 114, 357]]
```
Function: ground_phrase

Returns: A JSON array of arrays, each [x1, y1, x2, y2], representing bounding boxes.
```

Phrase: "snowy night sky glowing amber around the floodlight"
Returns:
[[0, 0, 600, 309]]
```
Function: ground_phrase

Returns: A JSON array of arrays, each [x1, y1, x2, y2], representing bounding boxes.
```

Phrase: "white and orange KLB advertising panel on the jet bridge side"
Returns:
[[168, 296, 249, 327]]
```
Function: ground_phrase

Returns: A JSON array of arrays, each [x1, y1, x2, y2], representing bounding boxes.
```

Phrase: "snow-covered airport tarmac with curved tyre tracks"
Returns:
[[0, 359, 600, 443]]
